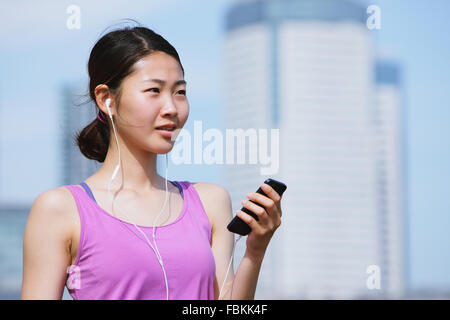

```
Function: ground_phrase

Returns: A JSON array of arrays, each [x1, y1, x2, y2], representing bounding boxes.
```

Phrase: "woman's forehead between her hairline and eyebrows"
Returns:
[[130, 51, 183, 82]]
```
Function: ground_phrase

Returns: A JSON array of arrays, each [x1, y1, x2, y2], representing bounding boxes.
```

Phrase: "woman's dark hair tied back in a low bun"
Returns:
[[75, 20, 184, 162]]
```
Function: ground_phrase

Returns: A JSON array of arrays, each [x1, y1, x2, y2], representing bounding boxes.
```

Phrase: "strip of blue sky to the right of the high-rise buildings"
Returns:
[[372, 0, 450, 288]]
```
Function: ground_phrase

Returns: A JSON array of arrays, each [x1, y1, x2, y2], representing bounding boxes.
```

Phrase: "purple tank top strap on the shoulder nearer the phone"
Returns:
[[177, 181, 211, 243]]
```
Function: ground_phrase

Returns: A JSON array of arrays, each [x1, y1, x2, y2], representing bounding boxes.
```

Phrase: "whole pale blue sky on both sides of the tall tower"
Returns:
[[0, 0, 450, 288]]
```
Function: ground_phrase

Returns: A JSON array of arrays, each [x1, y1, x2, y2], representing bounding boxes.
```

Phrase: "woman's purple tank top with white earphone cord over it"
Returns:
[[64, 181, 216, 300]]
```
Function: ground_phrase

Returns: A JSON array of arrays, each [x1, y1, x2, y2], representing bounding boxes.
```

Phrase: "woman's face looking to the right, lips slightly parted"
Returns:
[[114, 51, 189, 154]]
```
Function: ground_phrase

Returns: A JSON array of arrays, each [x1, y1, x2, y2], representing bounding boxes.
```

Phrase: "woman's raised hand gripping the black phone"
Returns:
[[236, 183, 282, 257]]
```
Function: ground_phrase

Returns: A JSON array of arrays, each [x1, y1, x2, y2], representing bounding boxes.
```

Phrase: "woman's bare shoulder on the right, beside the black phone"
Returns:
[[192, 182, 232, 230]]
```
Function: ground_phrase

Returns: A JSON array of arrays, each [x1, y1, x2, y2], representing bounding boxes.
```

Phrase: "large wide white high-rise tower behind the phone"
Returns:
[[223, 0, 403, 299]]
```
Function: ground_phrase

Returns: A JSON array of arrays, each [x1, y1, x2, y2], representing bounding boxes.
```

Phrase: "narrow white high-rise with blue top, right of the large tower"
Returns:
[[375, 61, 408, 299]]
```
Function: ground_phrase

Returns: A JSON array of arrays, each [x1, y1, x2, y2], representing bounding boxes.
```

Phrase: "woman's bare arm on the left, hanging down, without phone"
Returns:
[[21, 189, 72, 300]]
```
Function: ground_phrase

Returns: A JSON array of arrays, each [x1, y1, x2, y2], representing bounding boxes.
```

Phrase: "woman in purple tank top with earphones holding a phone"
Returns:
[[21, 23, 281, 299]]
